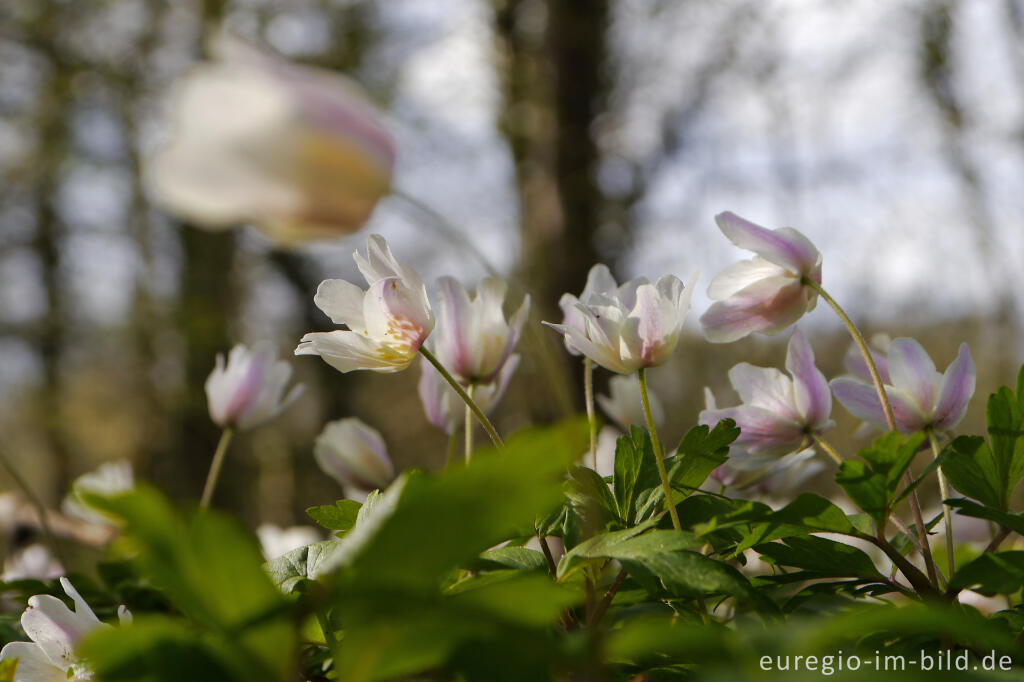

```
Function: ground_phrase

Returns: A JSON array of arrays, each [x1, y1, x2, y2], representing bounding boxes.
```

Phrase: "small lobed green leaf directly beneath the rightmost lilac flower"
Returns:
[[836, 432, 925, 525]]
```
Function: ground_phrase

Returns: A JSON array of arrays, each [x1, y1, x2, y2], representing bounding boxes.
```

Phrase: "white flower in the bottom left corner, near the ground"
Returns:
[[0, 578, 131, 682]]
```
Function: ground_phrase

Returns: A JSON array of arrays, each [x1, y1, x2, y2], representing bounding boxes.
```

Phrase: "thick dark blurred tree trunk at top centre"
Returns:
[[496, 0, 608, 319]]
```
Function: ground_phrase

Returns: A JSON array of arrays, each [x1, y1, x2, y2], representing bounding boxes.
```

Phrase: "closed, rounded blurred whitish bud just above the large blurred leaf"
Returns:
[[313, 417, 394, 499]]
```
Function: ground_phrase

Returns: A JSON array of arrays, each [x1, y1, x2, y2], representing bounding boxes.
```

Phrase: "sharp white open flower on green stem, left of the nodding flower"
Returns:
[[544, 274, 693, 374]]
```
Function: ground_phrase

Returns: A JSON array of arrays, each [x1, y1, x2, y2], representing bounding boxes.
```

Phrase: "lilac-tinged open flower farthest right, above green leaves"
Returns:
[[830, 337, 977, 433]]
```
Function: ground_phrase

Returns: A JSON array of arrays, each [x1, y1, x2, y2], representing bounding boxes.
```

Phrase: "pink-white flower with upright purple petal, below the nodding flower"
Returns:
[[699, 329, 836, 458]]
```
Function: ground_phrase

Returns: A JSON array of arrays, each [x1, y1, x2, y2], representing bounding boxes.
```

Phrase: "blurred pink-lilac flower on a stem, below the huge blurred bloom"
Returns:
[[206, 343, 302, 429]]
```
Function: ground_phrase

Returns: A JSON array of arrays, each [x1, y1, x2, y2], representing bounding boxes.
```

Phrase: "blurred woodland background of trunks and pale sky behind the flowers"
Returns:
[[0, 0, 1024, 548]]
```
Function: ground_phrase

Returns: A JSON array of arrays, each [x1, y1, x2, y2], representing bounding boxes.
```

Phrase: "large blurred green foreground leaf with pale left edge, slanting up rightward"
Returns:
[[317, 421, 587, 588]]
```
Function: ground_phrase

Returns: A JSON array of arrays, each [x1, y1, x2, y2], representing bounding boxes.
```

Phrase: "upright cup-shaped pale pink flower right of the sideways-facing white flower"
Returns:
[[434, 278, 529, 385]]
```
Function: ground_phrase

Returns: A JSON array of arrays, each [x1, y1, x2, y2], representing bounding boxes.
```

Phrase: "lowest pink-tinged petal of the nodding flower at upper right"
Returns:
[[700, 276, 817, 343]]
